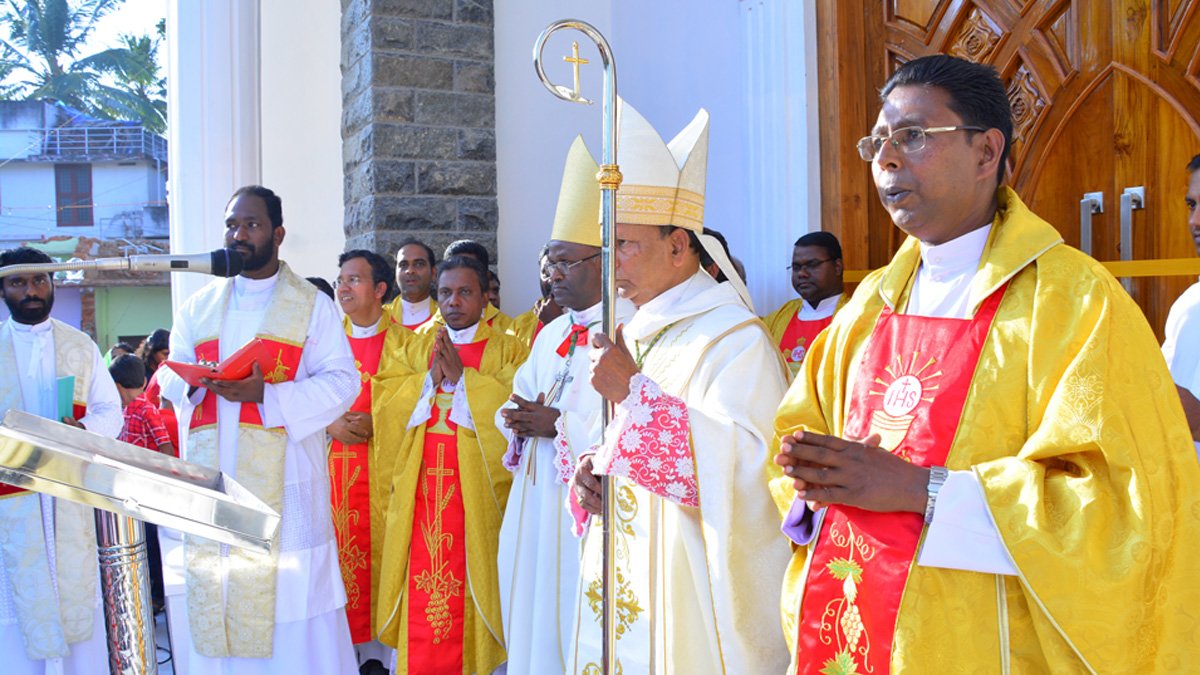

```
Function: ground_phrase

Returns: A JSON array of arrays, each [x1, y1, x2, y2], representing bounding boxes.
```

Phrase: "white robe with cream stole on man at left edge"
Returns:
[[0, 318, 124, 675]]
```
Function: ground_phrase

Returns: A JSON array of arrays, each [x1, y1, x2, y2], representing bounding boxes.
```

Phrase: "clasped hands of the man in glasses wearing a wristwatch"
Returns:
[[775, 431, 929, 513]]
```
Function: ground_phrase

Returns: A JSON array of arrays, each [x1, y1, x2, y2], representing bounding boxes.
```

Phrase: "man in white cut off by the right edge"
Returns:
[[1163, 155, 1200, 453]]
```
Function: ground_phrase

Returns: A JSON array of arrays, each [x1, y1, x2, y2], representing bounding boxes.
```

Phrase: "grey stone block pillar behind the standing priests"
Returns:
[[342, 0, 498, 263]]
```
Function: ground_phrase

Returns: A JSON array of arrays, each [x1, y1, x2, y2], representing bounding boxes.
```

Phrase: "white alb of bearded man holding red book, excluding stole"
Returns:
[[158, 270, 360, 675]]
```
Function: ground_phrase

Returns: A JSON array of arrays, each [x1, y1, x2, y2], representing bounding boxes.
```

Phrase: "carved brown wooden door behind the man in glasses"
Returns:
[[817, 0, 1200, 333]]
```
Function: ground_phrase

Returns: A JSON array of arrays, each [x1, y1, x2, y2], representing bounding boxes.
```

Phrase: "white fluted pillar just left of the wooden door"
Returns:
[[739, 0, 821, 316]]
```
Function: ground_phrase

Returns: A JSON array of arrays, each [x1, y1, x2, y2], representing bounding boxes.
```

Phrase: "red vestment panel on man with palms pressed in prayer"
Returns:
[[408, 340, 491, 674]]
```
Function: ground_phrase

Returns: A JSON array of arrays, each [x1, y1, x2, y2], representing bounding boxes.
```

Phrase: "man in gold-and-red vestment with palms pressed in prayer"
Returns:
[[372, 256, 528, 674]]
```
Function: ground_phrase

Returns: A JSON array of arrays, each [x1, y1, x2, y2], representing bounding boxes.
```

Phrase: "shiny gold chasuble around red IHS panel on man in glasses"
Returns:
[[770, 189, 1200, 673]]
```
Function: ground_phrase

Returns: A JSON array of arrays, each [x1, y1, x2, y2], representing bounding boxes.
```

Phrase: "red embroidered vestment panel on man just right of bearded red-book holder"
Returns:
[[329, 331, 388, 644]]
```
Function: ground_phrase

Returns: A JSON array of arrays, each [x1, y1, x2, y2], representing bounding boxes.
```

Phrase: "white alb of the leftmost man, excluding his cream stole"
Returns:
[[0, 318, 124, 675]]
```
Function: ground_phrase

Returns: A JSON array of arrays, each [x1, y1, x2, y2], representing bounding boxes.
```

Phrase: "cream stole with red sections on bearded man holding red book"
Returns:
[[185, 262, 317, 658]]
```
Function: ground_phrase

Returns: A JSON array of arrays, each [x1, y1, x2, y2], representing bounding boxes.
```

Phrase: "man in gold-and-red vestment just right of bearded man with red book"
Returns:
[[325, 249, 412, 668]]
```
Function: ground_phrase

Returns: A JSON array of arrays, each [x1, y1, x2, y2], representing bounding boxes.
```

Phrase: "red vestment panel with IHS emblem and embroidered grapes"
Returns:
[[797, 286, 1007, 675]]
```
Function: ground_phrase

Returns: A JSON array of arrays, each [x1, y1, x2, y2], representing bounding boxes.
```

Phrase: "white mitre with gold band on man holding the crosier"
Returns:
[[617, 98, 708, 233]]
